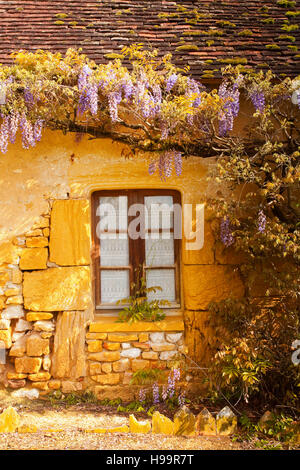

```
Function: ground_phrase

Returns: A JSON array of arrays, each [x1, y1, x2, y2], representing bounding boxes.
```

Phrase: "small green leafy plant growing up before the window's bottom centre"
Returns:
[[118, 273, 170, 323]]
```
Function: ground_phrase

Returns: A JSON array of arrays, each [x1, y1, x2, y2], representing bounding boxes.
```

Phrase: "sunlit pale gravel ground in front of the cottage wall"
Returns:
[[0, 401, 243, 450]]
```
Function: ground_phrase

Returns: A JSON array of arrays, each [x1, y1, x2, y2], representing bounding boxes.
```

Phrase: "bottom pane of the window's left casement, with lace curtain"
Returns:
[[101, 270, 129, 304]]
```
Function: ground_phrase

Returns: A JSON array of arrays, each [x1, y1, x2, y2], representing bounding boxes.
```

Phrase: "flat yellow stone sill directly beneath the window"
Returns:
[[89, 315, 184, 333]]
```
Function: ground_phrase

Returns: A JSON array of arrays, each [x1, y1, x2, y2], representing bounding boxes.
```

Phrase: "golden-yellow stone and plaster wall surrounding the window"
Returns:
[[0, 133, 244, 398]]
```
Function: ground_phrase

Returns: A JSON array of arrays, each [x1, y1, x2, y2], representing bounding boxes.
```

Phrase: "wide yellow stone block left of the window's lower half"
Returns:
[[23, 266, 90, 312]]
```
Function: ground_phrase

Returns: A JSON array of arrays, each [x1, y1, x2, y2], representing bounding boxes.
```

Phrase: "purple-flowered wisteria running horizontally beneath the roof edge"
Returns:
[[0, 45, 294, 187]]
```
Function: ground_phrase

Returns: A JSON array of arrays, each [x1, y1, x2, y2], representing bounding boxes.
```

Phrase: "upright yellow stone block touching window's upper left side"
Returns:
[[50, 199, 91, 266]]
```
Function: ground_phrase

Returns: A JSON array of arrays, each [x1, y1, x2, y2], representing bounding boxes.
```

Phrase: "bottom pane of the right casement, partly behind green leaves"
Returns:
[[146, 269, 176, 302]]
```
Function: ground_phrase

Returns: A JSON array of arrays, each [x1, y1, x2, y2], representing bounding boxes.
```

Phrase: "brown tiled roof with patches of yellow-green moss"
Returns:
[[0, 0, 300, 79]]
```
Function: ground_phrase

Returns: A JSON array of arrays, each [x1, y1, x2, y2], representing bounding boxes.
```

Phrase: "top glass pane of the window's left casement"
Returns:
[[98, 196, 128, 232]]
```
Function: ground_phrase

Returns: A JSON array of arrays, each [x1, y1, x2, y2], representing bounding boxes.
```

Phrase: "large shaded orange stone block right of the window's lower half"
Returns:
[[183, 265, 244, 310]]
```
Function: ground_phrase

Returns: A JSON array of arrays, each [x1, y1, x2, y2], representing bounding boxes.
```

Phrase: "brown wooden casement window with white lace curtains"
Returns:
[[93, 190, 181, 310]]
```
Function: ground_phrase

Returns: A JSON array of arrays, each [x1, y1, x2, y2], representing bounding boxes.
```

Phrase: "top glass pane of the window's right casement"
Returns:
[[145, 196, 173, 230]]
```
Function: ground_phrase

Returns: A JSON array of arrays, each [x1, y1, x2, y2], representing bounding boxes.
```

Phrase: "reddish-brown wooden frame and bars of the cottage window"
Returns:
[[92, 189, 181, 311]]
